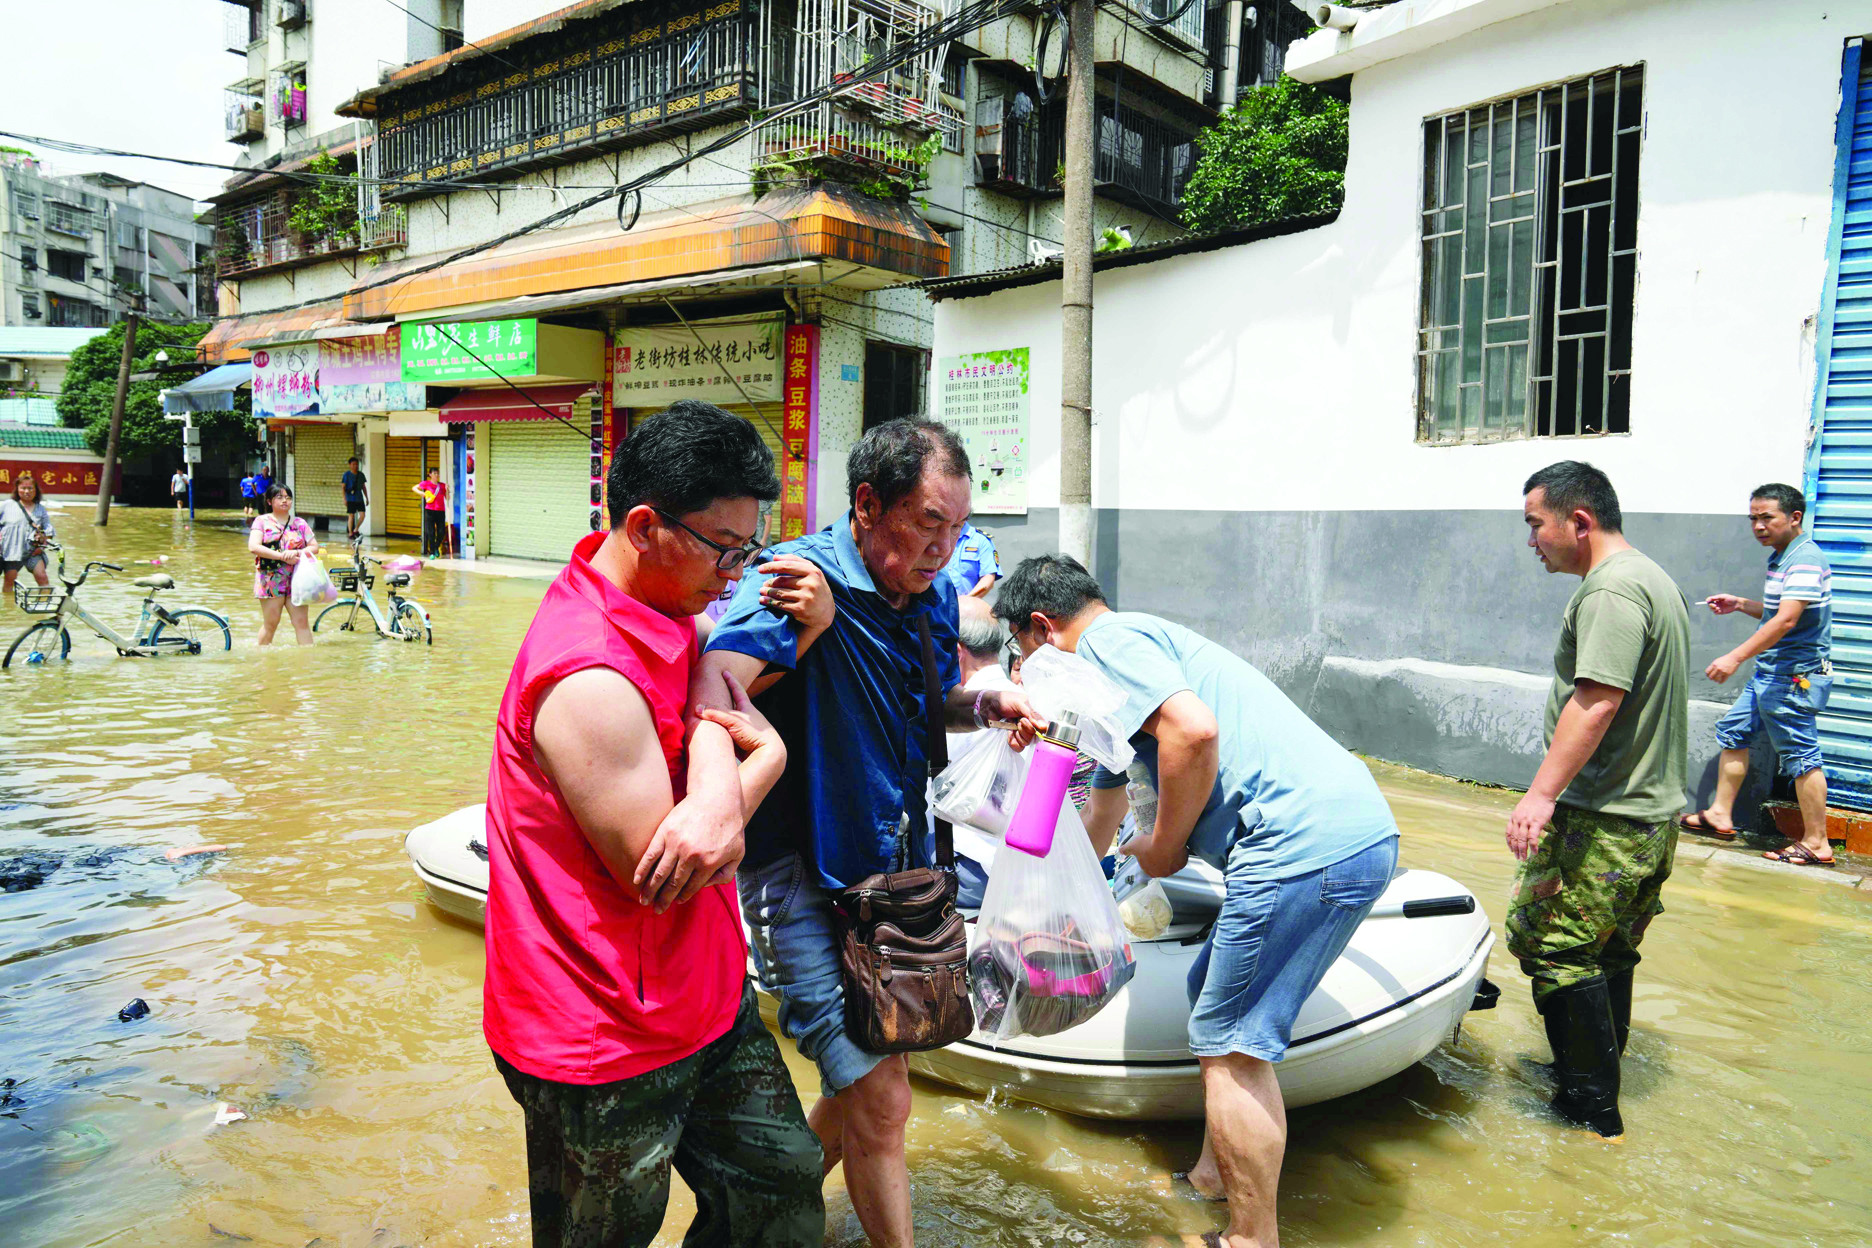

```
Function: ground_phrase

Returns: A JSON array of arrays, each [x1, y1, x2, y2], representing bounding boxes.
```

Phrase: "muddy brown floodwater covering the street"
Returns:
[[0, 507, 1872, 1248]]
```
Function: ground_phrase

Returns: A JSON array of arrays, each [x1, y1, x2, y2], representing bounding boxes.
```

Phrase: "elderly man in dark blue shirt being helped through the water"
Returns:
[[696, 419, 1039, 1248]]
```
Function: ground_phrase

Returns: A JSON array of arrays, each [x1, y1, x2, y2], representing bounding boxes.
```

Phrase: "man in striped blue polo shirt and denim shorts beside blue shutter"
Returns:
[[1683, 485, 1833, 866]]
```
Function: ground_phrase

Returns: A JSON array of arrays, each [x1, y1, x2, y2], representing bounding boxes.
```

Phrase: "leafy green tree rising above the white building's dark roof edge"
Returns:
[[1183, 77, 1348, 230]]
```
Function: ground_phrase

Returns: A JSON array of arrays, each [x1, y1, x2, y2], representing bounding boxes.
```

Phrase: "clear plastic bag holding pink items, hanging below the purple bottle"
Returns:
[[968, 803, 1138, 1040]]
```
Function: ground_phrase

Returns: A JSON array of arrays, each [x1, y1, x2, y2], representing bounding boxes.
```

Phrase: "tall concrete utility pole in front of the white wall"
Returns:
[[1060, 0, 1099, 569]]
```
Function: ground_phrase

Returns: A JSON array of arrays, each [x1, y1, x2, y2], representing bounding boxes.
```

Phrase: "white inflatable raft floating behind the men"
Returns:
[[404, 806, 1496, 1121]]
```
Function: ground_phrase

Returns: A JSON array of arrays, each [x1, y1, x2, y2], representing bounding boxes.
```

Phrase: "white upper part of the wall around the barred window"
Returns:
[[936, 0, 1849, 513]]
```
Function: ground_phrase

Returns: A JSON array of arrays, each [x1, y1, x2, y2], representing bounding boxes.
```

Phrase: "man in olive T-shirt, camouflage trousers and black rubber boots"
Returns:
[[1505, 460, 1690, 1136]]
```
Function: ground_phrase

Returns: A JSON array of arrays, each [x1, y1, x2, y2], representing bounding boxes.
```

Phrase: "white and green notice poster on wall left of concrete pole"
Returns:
[[936, 346, 1028, 515]]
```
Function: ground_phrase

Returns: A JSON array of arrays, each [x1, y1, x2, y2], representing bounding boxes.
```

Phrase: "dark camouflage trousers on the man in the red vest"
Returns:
[[494, 984, 826, 1248]]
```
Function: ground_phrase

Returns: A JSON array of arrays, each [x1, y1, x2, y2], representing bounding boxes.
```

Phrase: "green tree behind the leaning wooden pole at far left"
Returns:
[[58, 320, 253, 458]]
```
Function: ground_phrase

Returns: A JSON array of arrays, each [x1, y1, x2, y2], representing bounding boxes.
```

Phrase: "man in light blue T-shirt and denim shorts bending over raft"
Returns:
[[994, 556, 1398, 1244]]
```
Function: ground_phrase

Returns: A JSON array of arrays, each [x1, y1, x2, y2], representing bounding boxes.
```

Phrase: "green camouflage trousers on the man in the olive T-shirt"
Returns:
[[1505, 806, 1677, 1005]]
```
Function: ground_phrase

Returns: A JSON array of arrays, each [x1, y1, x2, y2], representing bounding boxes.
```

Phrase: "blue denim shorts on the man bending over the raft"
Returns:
[[1189, 836, 1398, 1061]]
